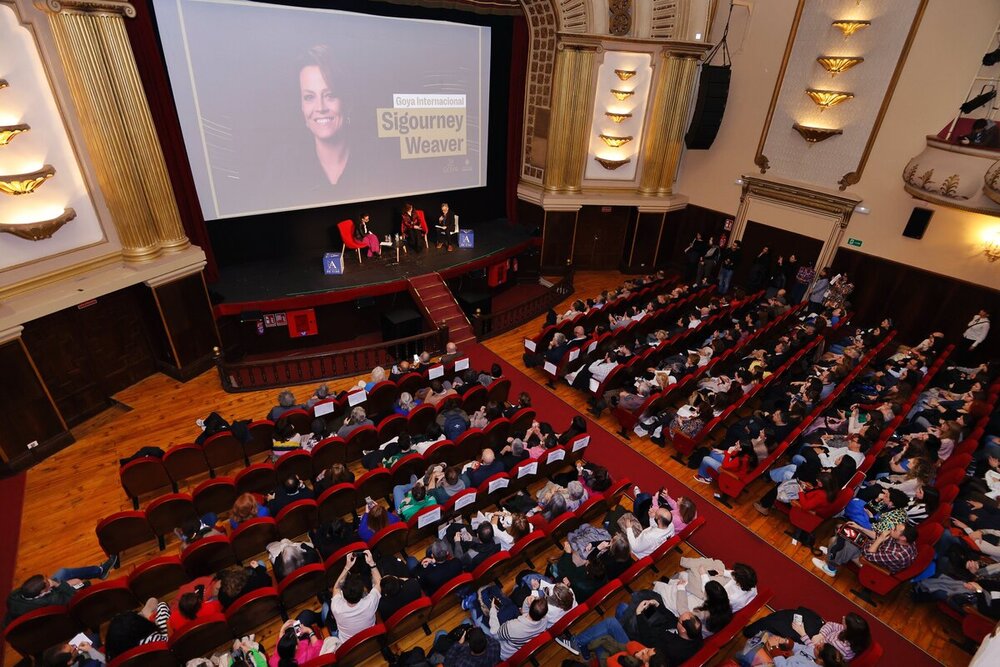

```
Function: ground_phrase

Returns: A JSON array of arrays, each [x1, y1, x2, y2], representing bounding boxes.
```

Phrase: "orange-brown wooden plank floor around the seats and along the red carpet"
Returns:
[[5, 272, 970, 666]]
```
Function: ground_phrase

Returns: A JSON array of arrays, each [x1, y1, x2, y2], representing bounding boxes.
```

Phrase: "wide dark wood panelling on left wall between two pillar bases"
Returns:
[[22, 285, 155, 426]]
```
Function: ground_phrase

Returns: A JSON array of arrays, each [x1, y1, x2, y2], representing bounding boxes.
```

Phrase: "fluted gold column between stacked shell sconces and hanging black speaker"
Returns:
[[639, 52, 698, 195]]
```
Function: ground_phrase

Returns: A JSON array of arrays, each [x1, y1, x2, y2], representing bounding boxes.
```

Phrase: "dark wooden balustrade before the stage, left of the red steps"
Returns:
[[213, 325, 448, 393]]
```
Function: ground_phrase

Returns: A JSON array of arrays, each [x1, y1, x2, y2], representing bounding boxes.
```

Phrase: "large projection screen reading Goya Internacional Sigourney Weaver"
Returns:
[[153, 0, 491, 219]]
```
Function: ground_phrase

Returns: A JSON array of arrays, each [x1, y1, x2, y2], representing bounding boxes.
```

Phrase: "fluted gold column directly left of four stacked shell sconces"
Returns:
[[544, 44, 597, 192]]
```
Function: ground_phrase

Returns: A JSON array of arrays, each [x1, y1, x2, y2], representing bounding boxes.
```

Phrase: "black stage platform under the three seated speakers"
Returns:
[[211, 220, 532, 310]]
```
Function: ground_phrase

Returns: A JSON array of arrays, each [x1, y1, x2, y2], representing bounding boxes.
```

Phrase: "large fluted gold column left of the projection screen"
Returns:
[[36, 0, 190, 261]]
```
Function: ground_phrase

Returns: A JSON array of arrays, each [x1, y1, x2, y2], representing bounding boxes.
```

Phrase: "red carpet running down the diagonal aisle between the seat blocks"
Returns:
[[466, 345, 939, 667]]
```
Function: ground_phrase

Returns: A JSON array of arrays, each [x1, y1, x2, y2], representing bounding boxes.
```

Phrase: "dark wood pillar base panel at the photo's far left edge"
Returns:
[[0, 340, 65, 464]]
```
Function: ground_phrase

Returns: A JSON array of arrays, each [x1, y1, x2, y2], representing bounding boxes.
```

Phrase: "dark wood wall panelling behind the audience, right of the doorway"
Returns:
[[832, 248, 1000, 344]]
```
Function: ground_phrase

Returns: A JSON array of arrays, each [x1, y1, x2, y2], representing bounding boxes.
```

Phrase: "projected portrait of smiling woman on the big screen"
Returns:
[[299, 45, 351, 185]]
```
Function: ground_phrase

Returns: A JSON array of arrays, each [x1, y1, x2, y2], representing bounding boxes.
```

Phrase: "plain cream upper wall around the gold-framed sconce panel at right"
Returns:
[[675, 0, 1000, 288]]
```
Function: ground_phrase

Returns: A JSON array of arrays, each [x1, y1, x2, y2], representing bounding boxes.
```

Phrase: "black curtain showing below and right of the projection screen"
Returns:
[[193, 0, 523, 268]]
